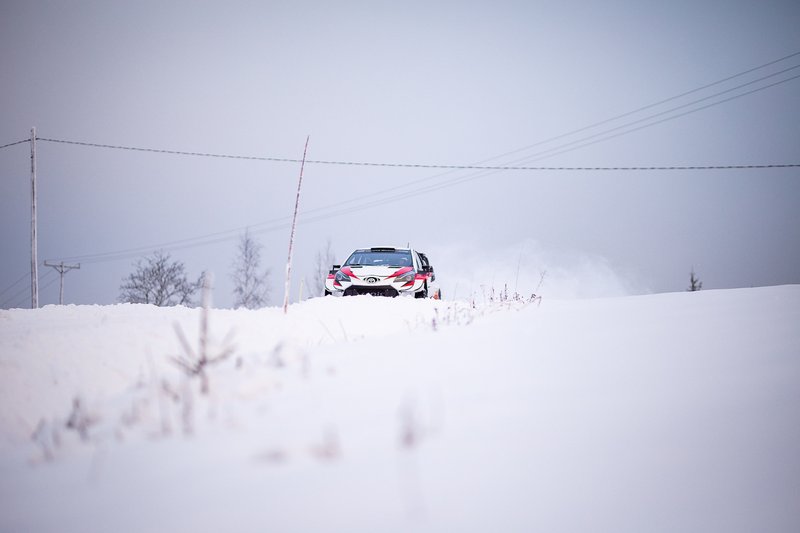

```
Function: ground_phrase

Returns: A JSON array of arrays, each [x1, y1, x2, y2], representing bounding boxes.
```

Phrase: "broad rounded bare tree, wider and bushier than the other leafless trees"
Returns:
[[119, 251, 203, 307]]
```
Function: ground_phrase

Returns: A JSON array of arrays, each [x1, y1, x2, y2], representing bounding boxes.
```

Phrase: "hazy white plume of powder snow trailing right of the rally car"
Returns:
[[426, 239, 635, 300]]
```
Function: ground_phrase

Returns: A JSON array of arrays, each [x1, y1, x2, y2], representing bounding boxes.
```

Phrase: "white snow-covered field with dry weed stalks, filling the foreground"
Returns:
[[0, 286, 800, 533]]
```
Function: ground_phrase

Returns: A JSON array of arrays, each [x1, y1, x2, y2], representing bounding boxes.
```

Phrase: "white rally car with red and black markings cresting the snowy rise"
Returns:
[[325, 247, 441, 298]]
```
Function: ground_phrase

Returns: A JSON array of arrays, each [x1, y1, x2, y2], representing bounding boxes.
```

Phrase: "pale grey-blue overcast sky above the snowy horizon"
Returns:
[[0, 0, 800, 307]]
